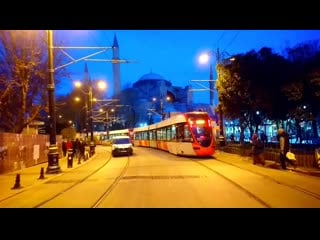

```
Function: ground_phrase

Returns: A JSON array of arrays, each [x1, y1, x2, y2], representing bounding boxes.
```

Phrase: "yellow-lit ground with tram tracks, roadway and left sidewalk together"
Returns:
[[0, 147, 320, 208]]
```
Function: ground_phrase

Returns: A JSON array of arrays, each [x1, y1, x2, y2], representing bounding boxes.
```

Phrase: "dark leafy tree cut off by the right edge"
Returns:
[[283, 41, 320, 139]]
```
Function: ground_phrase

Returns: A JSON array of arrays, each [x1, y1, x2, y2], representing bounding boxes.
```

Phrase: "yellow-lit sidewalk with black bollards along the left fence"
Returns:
[[0, 155, 91, 201]]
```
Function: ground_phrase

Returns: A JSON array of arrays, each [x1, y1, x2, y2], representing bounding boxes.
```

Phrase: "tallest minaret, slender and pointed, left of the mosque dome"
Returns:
[[112, 35, 121, 98]]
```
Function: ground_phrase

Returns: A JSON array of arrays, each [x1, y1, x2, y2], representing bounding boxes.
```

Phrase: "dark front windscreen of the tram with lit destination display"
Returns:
[[189, 115, 212, 147]]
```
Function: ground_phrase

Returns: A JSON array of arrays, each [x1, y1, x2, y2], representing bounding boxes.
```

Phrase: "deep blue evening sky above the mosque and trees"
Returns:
[[53, 30, 320, 103]]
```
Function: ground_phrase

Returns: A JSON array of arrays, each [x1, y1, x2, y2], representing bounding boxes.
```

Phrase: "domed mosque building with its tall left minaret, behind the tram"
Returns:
[[91, 35, 215, 130]]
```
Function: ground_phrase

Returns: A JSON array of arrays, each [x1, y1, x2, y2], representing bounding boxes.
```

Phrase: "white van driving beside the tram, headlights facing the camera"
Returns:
[[111, 136, 133, 157]]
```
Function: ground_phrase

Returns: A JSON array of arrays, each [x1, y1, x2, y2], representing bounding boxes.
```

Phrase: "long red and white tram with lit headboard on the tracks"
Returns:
[[133, 112, 216, 157]]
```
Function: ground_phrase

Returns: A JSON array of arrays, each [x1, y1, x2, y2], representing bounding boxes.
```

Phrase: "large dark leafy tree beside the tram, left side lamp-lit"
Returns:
[[217, 48, 290, 142]]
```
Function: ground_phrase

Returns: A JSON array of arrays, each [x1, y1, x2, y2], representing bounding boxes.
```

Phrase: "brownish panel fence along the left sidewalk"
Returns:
[[0, 133, 62, 174]]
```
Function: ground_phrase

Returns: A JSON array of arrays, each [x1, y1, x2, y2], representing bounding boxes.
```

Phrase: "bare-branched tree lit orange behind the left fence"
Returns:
[[0, 30, 66, 133]]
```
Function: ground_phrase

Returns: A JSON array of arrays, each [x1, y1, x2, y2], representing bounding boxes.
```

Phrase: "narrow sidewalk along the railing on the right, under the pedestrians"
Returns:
[[215, 150, 320, 177]]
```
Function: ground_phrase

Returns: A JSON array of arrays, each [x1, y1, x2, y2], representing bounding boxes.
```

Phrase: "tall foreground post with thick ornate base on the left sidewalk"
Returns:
[[46, 30, 61, 174]]
